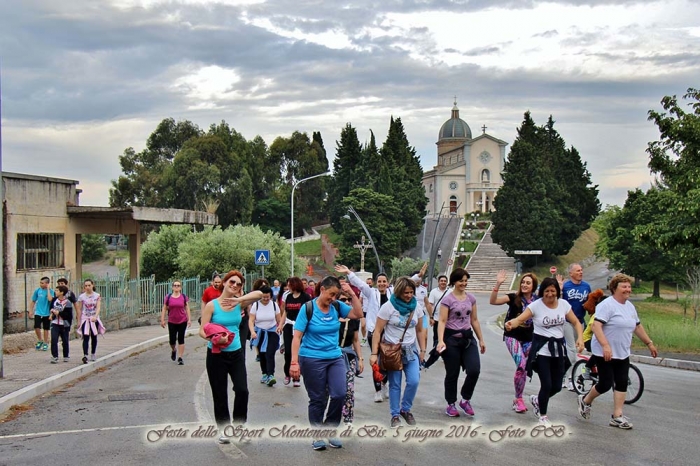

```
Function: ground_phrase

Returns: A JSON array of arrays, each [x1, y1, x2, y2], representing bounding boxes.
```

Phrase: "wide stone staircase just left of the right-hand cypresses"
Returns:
[[467, 228, 515, 292]]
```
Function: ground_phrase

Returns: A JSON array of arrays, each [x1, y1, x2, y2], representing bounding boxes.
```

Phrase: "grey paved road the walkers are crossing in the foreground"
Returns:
[[0, 295, 700, 465]]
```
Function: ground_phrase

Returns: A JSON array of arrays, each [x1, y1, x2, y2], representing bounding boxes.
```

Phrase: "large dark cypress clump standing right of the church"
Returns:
[[492, 112, 600, 265]]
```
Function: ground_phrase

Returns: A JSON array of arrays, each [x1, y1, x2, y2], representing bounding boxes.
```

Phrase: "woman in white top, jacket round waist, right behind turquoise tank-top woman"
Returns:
[[248, 285, 284, 387]]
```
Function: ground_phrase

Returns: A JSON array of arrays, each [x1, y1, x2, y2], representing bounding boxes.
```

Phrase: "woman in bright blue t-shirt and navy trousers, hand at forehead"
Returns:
[[289, 276, 363, 450]]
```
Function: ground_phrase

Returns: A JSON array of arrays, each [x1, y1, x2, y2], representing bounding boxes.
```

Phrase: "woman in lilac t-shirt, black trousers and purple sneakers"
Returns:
[[435, 268, 486, 417]]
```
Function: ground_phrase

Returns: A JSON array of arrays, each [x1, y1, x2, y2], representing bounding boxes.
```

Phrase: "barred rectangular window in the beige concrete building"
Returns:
[[17, 233, 64, 270]]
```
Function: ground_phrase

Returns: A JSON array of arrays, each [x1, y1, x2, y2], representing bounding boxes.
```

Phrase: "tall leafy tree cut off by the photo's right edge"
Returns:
[[639, 88, 700, 267]]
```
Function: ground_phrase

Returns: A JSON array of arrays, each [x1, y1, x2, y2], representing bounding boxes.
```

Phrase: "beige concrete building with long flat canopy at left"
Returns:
[[2, 172, 217, 317]]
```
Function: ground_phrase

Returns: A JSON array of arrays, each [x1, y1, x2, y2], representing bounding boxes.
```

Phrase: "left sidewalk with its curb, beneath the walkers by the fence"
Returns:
[[0, 323, 199, 414]]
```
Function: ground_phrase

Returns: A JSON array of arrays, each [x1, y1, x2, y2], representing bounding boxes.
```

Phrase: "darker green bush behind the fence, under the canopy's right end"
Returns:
[[141, 225, 193, 281]]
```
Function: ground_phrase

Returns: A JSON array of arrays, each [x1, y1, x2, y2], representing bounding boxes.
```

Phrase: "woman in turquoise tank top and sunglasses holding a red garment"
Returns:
[[199, 270, 262, 443]]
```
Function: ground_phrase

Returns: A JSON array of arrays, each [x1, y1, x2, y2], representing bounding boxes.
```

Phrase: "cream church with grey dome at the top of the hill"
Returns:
[[423, 101, 508, 216]]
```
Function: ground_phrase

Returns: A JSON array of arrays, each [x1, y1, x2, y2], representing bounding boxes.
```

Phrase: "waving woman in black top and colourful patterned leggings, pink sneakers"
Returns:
[[489, 270, 537, 413]]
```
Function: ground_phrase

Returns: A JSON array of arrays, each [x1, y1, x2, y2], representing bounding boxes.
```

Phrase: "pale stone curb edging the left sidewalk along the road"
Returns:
[[0, 327, 199, 414]]
